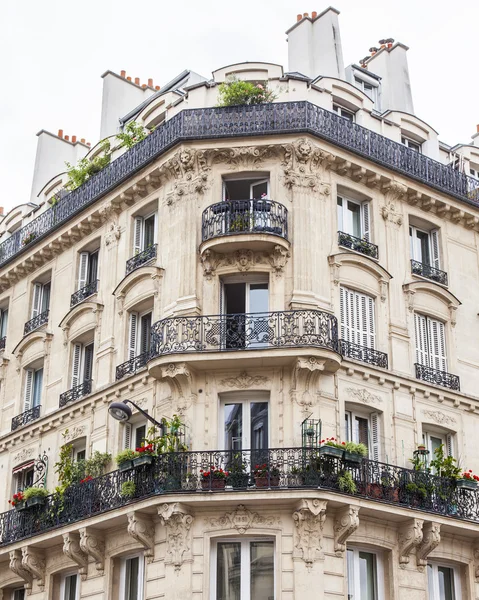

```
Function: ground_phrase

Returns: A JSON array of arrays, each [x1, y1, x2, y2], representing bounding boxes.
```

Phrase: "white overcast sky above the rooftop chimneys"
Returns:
[[0, 0, 479, 209]]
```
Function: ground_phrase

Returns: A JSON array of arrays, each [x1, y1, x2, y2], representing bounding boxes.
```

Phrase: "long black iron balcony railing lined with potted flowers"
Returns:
[[0, 448, 479, 546]]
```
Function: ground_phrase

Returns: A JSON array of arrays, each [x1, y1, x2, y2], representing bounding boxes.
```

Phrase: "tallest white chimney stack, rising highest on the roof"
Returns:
[[286, 7, 345, 79]]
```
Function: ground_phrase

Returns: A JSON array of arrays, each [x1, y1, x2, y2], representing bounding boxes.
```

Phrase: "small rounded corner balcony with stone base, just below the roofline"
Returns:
[[200, 199, 289, 252]]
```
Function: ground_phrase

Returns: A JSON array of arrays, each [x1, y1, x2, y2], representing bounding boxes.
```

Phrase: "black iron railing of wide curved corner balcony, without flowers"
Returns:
[[151, 310, 338, 357]]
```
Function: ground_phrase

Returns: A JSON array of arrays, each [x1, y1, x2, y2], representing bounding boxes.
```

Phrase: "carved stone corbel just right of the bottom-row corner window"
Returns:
[[293, 500, 328, 569]]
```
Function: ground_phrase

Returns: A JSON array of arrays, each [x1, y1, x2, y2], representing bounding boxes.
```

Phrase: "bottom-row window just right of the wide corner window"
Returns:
[[347, 548, 384, 600]]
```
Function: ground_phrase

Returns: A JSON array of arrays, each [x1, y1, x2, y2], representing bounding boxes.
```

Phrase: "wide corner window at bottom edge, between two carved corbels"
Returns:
[[211, 539, 275, 600]]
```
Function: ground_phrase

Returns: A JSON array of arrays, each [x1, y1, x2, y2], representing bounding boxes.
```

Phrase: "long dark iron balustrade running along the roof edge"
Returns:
[[0, 101, 479, 265]]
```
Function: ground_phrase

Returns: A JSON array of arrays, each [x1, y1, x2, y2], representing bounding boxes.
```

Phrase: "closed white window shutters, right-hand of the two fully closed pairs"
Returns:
[[414, 313, 447, 371]]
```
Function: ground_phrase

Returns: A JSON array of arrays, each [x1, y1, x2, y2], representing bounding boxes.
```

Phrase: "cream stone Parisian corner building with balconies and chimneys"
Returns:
[[0, 9, 479, 600]]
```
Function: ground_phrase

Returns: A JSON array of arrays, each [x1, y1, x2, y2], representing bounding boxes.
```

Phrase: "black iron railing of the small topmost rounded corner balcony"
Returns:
[[202, 200, 288, 241]]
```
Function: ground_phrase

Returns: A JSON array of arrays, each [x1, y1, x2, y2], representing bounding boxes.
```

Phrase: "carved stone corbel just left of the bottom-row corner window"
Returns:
[[158, 502, 193, 571]]
